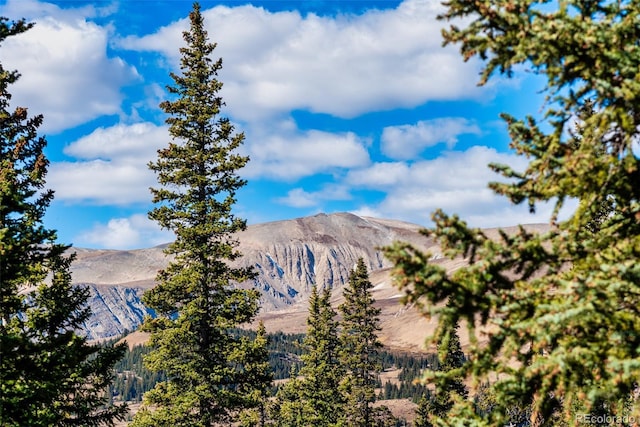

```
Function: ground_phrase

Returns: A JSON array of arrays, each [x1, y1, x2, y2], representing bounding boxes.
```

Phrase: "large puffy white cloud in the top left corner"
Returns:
[[0, 0, 139, 133]]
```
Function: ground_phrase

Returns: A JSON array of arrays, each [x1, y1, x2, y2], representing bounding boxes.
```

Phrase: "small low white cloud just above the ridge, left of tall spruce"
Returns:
[[76, 214, 174, 249]]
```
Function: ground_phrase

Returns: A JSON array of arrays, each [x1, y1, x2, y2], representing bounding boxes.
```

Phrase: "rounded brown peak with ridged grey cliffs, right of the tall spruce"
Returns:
[[232, 213, 427, 311]]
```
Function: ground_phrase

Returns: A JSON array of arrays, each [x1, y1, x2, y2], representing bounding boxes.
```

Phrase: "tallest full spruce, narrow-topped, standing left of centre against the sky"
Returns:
[[133, 3, 268, 427]]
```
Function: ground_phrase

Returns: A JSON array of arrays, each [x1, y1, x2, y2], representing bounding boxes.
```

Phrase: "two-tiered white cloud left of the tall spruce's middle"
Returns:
[[47, 123, 169, 205]]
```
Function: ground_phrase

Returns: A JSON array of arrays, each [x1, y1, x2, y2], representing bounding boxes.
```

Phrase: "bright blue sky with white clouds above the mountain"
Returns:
[[0, 0, 550, 249]]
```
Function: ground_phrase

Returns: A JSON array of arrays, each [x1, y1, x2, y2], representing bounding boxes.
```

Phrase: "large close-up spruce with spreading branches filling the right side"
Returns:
[[387, 0, 640, 425]]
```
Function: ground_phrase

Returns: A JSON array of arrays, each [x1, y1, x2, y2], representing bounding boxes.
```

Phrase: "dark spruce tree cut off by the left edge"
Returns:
[[0, 17, 127, 426]]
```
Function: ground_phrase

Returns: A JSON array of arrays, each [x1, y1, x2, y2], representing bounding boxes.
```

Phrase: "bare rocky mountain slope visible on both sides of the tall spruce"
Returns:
[[72, 213, 433, 339]]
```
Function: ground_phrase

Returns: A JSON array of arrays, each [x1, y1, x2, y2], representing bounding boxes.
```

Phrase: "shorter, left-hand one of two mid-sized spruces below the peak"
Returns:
[[300, 286, 344, 426]]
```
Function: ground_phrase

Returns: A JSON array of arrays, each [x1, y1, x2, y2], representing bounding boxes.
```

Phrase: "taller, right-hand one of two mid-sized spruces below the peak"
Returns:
[[339, 258, 382, 427]]
